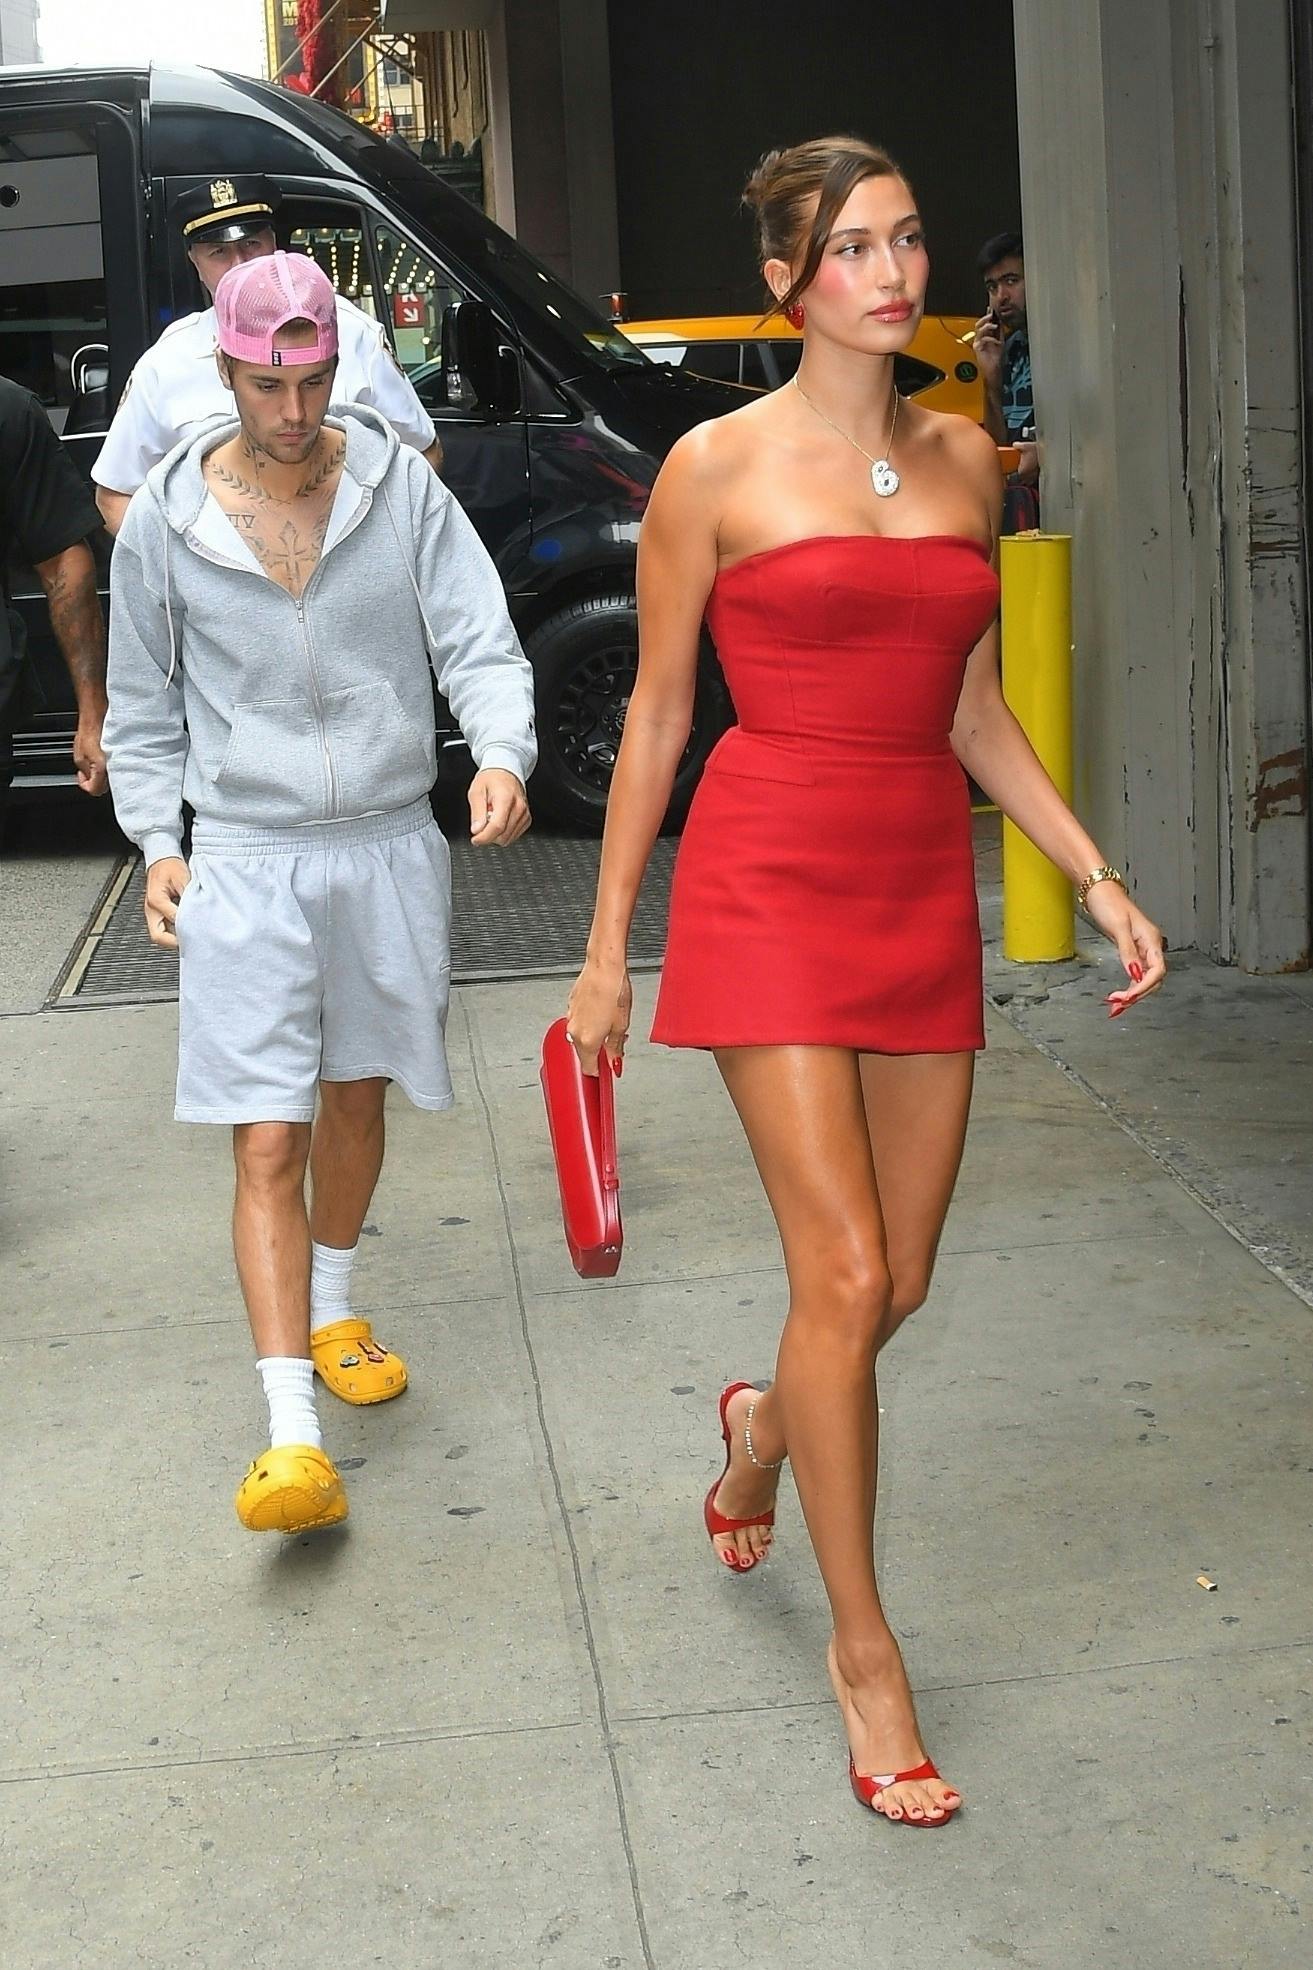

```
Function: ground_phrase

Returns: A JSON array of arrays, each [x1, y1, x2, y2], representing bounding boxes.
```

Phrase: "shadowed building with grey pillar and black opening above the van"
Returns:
[[388, 0, 1019, 313]]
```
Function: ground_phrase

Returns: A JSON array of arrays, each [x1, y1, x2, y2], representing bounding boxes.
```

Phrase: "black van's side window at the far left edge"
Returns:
[[0, 118, 108, 431]]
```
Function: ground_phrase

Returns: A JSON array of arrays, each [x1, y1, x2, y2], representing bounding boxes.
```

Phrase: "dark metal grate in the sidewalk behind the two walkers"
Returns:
[[47, 831, 676, 1009]]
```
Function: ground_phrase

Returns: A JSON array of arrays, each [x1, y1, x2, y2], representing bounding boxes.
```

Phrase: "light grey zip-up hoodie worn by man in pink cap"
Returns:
[[104, 404, 538, 863]]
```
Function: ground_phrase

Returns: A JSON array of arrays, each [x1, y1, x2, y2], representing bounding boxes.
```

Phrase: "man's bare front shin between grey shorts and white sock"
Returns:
[[233, 1121, 310, 1359]]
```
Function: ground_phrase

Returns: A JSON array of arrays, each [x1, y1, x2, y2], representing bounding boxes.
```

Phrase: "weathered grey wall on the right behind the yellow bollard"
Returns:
[[1015, 0, 1309, 971]]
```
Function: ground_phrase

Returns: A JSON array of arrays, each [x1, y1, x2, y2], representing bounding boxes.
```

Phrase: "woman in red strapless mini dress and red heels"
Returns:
[[570, 138, 1165, 1826]]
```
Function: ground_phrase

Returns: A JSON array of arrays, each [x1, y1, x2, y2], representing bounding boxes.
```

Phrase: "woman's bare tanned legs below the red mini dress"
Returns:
[[716, 1048, 970, 1818]]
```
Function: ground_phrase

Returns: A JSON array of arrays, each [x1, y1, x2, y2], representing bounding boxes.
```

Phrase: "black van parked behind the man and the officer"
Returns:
[[0, 67, 743, 825]]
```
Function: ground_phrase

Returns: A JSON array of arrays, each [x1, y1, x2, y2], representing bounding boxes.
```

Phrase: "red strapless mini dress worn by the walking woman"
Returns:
[[653, 534, 998, 1054]]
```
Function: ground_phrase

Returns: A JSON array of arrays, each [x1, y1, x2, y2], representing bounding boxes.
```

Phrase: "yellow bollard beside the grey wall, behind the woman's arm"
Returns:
[[1000, 534, 1076, 965]]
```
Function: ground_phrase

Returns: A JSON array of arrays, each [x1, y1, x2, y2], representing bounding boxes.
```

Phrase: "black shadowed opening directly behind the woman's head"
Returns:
[[609, 0, 1021, 317]]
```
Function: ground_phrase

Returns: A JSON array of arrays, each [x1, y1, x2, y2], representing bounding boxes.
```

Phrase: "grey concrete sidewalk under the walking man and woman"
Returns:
[[0, 929, 1313, 1970]]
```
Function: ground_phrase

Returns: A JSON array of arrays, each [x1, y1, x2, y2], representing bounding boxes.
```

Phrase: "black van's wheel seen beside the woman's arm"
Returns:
[[524, 593, 731, 835]]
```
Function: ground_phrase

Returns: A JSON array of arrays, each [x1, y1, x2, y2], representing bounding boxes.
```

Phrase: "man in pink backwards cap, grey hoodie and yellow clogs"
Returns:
[[104, 252, 536, 1533]]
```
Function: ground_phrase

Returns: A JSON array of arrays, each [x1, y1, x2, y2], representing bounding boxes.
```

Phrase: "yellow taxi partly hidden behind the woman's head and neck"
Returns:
[[615, 315, 984, 424]]
